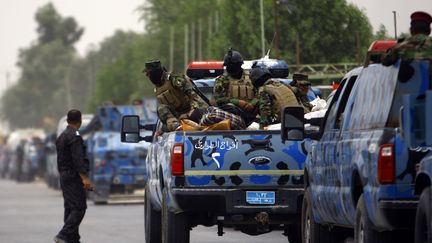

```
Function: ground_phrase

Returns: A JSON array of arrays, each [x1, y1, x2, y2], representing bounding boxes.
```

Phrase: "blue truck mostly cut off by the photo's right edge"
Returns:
[[401, 87, 432, 243]]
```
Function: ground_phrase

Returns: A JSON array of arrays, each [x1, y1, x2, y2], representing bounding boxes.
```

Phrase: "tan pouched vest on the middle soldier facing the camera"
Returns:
[[228, 73, 255, 101]]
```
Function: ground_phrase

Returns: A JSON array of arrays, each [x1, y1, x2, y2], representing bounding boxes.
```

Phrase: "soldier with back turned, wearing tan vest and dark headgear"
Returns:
[[250, 66, 301, 128]]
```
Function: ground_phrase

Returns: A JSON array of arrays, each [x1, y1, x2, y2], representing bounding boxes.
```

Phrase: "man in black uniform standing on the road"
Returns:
[[54, 110, 93, 243]]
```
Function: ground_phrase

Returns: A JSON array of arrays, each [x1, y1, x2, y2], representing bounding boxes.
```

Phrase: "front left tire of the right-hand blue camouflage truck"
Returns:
[[300, 189, 334, 243]]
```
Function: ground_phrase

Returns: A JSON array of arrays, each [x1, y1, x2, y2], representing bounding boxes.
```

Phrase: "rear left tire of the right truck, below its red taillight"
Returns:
[[354, 194, 392, 243]]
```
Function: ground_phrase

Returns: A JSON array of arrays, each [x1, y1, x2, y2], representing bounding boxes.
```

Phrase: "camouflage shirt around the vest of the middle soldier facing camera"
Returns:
[[213, 72, 257, 106]]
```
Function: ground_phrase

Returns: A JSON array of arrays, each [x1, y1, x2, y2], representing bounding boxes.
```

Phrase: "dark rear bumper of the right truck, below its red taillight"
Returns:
[[378, 200, 418, 229]]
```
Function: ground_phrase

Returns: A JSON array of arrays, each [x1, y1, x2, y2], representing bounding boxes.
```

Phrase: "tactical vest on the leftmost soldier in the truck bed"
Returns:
[[155, 77, 191, 111]]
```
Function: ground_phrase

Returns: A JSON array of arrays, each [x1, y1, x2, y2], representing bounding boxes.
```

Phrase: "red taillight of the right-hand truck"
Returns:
[[378, 144, 395, 184]]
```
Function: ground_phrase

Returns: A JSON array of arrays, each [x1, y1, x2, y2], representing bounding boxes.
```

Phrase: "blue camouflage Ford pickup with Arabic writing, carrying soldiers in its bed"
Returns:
[[121, 79, 311, 243]]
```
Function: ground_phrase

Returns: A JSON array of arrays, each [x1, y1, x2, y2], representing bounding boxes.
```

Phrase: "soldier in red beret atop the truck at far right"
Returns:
[[383, 12, 432, 67]]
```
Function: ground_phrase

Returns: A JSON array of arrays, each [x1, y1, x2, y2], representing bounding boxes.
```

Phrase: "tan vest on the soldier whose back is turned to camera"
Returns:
[[259, 82, 300, 119]]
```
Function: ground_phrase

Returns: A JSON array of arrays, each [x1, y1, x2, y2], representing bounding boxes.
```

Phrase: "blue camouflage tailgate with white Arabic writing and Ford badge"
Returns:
[[180, 131, 310, 187]]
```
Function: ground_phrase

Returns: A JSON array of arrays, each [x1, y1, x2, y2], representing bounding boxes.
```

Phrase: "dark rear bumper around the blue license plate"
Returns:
[[172, 188, 304, 219]]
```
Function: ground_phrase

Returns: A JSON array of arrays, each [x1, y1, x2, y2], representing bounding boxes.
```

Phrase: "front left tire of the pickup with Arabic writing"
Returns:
[[144, 188, 162, 243]]
